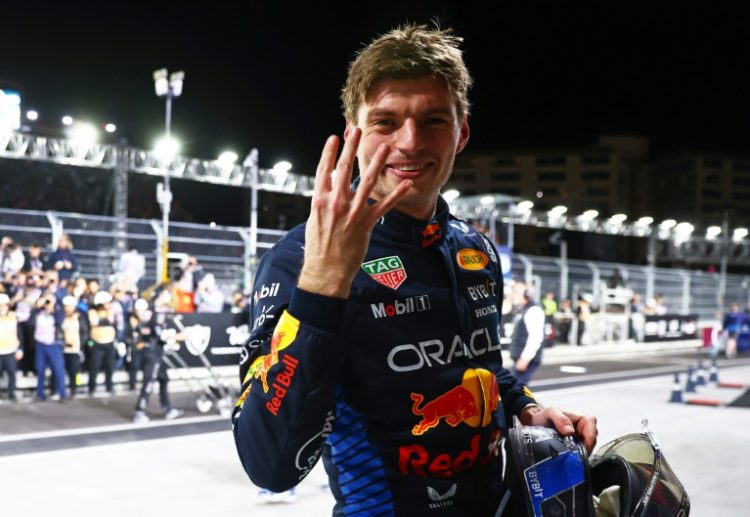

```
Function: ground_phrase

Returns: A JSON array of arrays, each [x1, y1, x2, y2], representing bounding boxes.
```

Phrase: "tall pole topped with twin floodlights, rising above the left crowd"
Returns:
[[154, 68, 185, 283]]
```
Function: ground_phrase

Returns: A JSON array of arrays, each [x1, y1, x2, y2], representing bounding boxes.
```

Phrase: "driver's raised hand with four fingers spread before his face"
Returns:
[[298, 128, 412, 298]]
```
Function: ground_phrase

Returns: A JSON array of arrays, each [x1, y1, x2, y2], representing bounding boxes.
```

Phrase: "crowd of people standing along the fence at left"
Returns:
[[0, 235, 253, 408]]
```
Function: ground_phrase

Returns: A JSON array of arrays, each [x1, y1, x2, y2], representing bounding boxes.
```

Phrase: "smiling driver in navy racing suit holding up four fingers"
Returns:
[[233, 22, 596, 515]]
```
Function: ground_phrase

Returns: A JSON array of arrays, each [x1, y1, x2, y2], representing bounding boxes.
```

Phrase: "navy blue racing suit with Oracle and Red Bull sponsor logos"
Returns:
[[233, 198, 535, 516]]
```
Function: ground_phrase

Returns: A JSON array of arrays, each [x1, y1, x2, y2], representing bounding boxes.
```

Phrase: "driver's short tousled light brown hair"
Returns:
[[341, 24, 472, 123]]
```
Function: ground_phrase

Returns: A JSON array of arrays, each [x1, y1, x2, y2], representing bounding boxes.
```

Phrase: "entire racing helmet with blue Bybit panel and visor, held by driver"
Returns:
[[502, 417, 690, 517]]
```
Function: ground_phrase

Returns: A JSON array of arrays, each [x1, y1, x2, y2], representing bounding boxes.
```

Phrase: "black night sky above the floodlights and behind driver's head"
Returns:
[[0, 1, 750, 173]]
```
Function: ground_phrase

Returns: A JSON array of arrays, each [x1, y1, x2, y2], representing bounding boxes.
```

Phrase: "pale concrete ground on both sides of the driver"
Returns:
[[0, 340, 750, 517]]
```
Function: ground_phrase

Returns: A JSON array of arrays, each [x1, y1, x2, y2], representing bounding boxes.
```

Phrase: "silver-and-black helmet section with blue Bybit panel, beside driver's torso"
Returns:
[[505, 417, 595, 517]]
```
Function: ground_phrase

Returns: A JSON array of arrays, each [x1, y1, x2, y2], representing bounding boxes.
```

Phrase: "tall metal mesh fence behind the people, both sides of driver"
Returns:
[[0, 208, 750, 320]]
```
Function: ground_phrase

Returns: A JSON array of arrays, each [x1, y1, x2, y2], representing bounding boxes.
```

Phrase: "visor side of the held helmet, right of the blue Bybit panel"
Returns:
[[591, 422, 690, 517]]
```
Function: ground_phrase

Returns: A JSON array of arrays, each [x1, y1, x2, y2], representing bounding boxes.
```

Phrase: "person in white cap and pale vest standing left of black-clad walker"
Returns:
[[88, 291, 117, 395]]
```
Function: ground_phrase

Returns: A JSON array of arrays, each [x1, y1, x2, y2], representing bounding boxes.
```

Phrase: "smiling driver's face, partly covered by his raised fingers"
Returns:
[[345, 77, 469, 219]]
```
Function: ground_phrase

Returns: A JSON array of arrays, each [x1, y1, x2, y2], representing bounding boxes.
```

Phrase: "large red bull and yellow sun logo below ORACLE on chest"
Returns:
[[411, 368, 500, 436]]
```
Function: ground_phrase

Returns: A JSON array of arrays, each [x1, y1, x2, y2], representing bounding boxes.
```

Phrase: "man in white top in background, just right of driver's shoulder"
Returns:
[[510, 282, 545, 385]]
